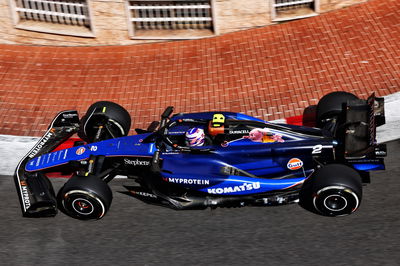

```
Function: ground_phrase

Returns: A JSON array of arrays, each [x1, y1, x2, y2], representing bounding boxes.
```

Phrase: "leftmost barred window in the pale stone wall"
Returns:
[[10, 0, 94, 37]]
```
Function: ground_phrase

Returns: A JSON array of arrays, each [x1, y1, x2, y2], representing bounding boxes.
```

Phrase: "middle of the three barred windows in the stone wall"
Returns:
[[127, 0, 214, 39]]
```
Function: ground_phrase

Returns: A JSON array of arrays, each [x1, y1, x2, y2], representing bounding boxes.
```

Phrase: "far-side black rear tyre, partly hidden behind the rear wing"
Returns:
[[317, 91, 358, 128]]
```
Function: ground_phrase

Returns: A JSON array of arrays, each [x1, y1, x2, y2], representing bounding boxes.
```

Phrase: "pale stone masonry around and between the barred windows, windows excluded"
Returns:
[[0, 0, 367, 46]]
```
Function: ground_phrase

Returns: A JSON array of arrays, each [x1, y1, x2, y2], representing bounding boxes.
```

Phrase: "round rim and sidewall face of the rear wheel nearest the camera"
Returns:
[[313, 186, 360, 216]]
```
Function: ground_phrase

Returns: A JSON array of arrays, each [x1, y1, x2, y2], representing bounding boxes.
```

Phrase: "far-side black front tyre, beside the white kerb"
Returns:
[[78, 101, 131, 143]]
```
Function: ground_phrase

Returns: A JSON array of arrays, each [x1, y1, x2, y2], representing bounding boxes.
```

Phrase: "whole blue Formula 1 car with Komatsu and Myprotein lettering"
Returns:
[[14, 92, 386, 220]]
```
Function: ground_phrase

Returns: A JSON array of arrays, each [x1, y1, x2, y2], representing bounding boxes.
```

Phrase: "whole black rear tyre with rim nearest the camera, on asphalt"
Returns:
[[311, 164, 362, 216]]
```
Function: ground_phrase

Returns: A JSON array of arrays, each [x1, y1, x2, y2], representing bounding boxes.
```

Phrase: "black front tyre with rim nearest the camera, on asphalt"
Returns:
[[57, 176, 112, 220]]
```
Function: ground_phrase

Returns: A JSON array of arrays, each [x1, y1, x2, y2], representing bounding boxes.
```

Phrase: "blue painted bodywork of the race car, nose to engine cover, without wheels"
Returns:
[[25, 112, 380, 196]]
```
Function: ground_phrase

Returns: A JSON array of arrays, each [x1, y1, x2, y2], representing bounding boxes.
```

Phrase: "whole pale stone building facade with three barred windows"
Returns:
[[0, 0, 367, 46]]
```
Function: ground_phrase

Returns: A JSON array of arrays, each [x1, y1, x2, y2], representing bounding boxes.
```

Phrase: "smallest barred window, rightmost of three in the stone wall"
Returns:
[[270, 0, 319, 21]]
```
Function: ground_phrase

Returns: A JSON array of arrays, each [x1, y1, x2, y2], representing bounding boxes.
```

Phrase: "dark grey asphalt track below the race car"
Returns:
[[0, 140, 400, 265]]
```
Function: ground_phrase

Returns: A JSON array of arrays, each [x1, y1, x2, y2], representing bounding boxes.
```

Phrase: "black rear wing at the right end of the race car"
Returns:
[[344, 93, 386, 159]]
